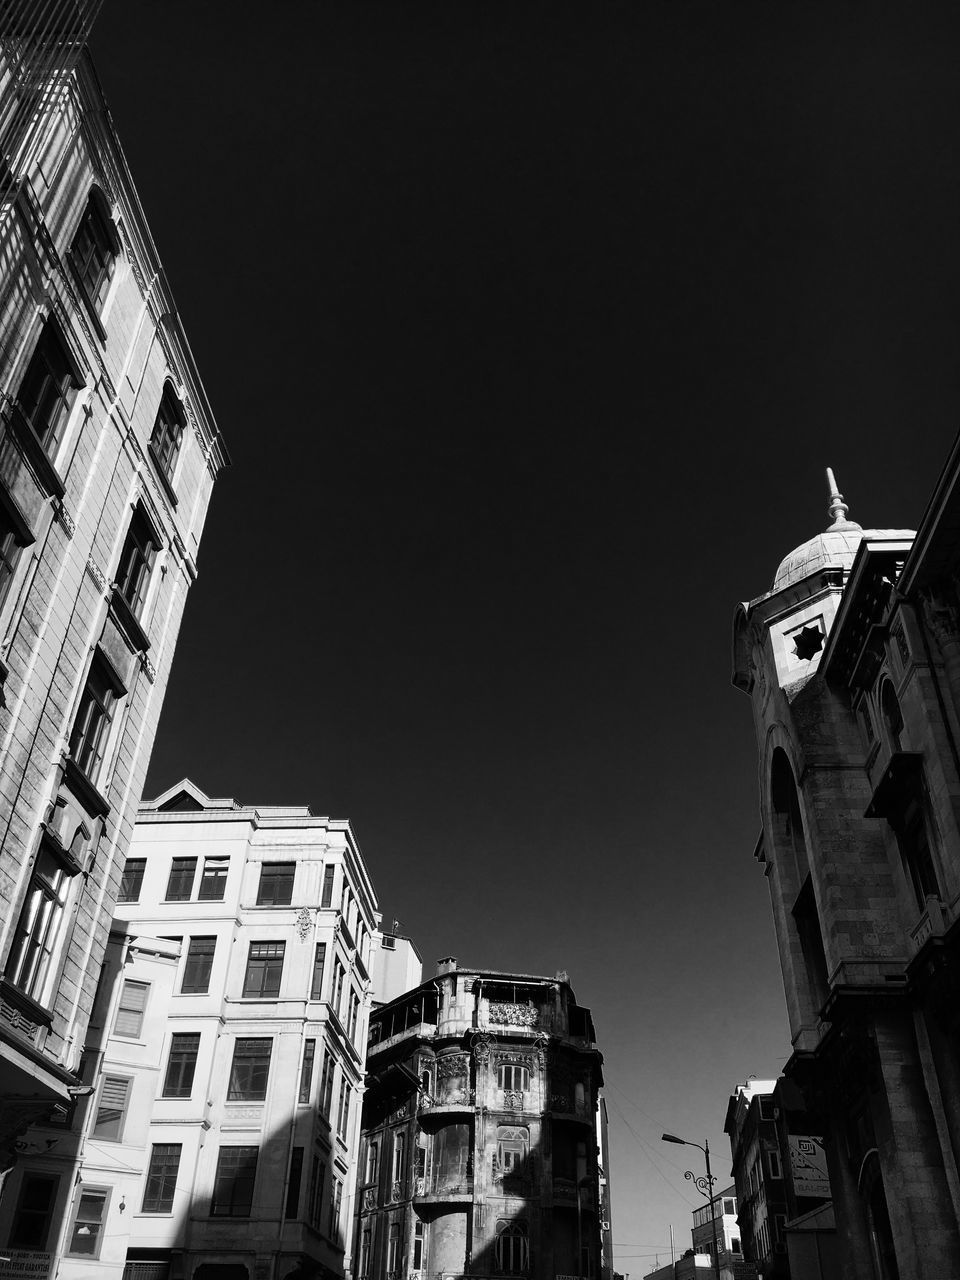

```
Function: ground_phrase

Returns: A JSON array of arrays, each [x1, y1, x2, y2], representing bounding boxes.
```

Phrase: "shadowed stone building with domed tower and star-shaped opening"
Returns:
[[733, 463, 960, 1280]]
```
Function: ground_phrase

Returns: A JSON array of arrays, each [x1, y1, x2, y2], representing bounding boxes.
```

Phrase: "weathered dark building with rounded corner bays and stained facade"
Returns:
[[355, 959, 604, 1280]]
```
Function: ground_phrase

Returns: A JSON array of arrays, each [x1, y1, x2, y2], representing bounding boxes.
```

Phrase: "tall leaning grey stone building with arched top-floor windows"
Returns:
[[0, 10, 227, 1172]]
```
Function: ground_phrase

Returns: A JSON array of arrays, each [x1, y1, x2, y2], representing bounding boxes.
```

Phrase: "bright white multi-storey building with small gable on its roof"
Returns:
[[53, 782, 379, 1280]]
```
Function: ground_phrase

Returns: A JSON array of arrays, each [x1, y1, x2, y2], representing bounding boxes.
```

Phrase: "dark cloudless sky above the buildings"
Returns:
[[93, 0, 960, 1276]]
